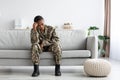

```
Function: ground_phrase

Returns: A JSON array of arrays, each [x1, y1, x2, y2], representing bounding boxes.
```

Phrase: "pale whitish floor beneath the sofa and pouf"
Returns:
[[0, 60, 120, 80]]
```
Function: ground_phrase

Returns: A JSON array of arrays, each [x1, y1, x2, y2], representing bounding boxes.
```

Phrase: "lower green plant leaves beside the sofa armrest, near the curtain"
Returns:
[[98, 35, 110, 57]]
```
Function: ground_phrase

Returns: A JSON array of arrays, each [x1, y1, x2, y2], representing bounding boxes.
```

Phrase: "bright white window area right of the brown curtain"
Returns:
[[110, 0, 120, 60]]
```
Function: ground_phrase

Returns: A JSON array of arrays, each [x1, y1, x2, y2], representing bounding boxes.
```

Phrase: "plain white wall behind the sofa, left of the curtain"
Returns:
[[0, 0, 104, 30]]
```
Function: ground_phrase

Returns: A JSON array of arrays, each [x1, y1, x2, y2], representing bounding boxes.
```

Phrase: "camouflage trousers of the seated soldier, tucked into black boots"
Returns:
[[31, 43, 62, 65]]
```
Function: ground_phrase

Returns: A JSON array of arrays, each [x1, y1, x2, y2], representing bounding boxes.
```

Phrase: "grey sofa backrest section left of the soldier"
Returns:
[[0, 30, 31, 50]]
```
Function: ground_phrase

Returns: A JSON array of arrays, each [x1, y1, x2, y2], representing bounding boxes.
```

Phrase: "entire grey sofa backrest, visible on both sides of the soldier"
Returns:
[[0, 30, 86, 50]]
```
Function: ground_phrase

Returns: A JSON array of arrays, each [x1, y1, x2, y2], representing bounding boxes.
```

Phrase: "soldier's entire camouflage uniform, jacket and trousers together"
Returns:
[[31, 25, 62, 65]]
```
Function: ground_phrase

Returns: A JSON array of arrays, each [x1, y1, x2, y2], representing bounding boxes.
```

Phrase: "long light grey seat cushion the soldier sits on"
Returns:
[[0, 50, 91, 59]]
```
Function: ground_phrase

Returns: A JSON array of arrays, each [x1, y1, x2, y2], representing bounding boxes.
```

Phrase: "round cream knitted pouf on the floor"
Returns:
[[84, 59, 111, 77]]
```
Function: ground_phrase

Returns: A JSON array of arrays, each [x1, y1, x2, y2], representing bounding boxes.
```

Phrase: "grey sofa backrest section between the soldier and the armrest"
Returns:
[[56, 30, 86, 50]]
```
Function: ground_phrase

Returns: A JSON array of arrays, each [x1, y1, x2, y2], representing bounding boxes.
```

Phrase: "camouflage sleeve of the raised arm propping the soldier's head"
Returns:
[[31, 29, 39, 44]]
